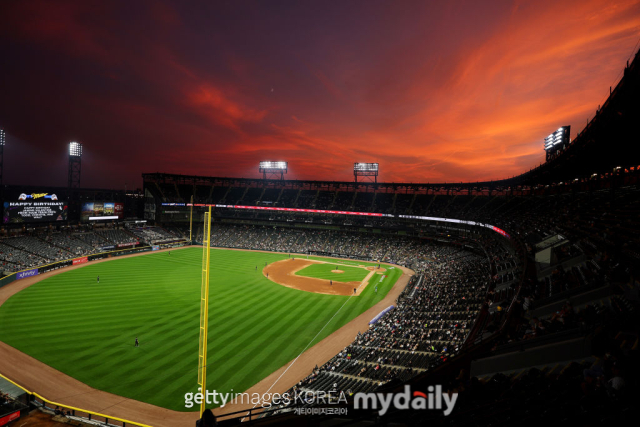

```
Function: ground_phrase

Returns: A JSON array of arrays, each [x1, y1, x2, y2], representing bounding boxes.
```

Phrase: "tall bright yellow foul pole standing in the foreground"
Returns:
[[198, 206, 211, 416]]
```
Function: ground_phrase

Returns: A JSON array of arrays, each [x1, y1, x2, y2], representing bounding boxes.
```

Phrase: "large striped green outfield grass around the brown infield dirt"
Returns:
[[0, 248, 401, 411]]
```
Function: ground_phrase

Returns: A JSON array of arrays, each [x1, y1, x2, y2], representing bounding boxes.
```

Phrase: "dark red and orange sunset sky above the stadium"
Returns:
[[0, 0, 640, 188]]
